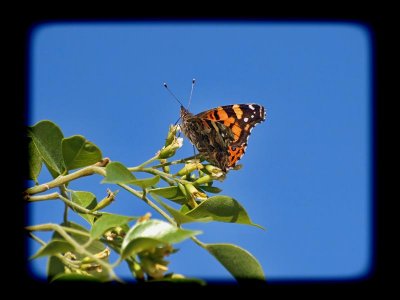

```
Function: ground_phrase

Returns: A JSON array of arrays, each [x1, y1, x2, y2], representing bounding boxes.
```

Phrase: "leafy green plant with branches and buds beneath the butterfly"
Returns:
[[25, 121, 265, 285]]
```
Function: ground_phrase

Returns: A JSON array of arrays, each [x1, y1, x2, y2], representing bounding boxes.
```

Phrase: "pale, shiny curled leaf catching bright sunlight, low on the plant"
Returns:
[[121, 220, 201, 258]]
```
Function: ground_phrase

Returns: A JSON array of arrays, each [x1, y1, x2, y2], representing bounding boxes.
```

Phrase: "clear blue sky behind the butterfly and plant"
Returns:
[[29, 22, 373, 281]]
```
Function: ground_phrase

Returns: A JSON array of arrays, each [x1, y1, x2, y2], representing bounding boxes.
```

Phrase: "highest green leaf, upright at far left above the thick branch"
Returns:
[[28, 121, 66, 177]]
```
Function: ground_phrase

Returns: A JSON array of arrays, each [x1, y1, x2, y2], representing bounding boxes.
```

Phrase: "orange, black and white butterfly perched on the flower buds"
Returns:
[[181, 103, 265, 172]]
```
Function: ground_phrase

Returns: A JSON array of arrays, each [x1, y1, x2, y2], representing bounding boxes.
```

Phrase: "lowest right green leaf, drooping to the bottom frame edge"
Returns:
[[205, 244, 265, 282]]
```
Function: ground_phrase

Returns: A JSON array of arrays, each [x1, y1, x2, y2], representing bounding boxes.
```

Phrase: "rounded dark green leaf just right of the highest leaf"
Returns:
[[62, 135, 103, 170]]
